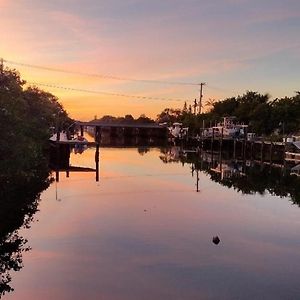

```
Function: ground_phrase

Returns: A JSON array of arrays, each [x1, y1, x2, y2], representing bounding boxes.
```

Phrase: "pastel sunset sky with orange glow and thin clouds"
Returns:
[[0, 0, 300, 120]]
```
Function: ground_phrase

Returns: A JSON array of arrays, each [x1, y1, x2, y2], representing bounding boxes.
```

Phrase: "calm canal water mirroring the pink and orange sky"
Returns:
[[4, 148, 300, 300]]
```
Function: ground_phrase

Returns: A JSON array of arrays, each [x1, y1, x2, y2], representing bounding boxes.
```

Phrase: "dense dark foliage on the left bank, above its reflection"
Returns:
[[0, 69, 71, 171]]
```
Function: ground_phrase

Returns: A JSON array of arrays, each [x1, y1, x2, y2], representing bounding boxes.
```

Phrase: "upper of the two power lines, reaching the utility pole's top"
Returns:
[[3, 59, 199, 86]]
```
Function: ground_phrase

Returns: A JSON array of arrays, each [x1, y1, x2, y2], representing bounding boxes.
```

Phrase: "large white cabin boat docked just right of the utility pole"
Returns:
[[203, 117, 248, 138]]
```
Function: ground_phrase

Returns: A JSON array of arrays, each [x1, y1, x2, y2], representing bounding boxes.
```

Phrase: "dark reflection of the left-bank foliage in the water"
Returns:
[[0, 156, 50, 298]]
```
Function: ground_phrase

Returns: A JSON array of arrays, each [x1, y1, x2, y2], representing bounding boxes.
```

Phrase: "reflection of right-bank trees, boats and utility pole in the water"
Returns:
[[160, 147, 300, 206]]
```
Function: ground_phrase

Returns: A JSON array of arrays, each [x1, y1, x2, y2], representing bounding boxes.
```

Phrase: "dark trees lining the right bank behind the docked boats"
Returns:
[[157, 91, 300, 135]]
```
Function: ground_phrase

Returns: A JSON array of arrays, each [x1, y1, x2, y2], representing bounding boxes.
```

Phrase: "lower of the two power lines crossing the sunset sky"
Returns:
[[27, 82, 186, 102]]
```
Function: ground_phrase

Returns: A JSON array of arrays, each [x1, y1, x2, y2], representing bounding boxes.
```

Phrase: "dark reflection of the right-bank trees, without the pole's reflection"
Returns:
[[160, 148, 300, 206]]
